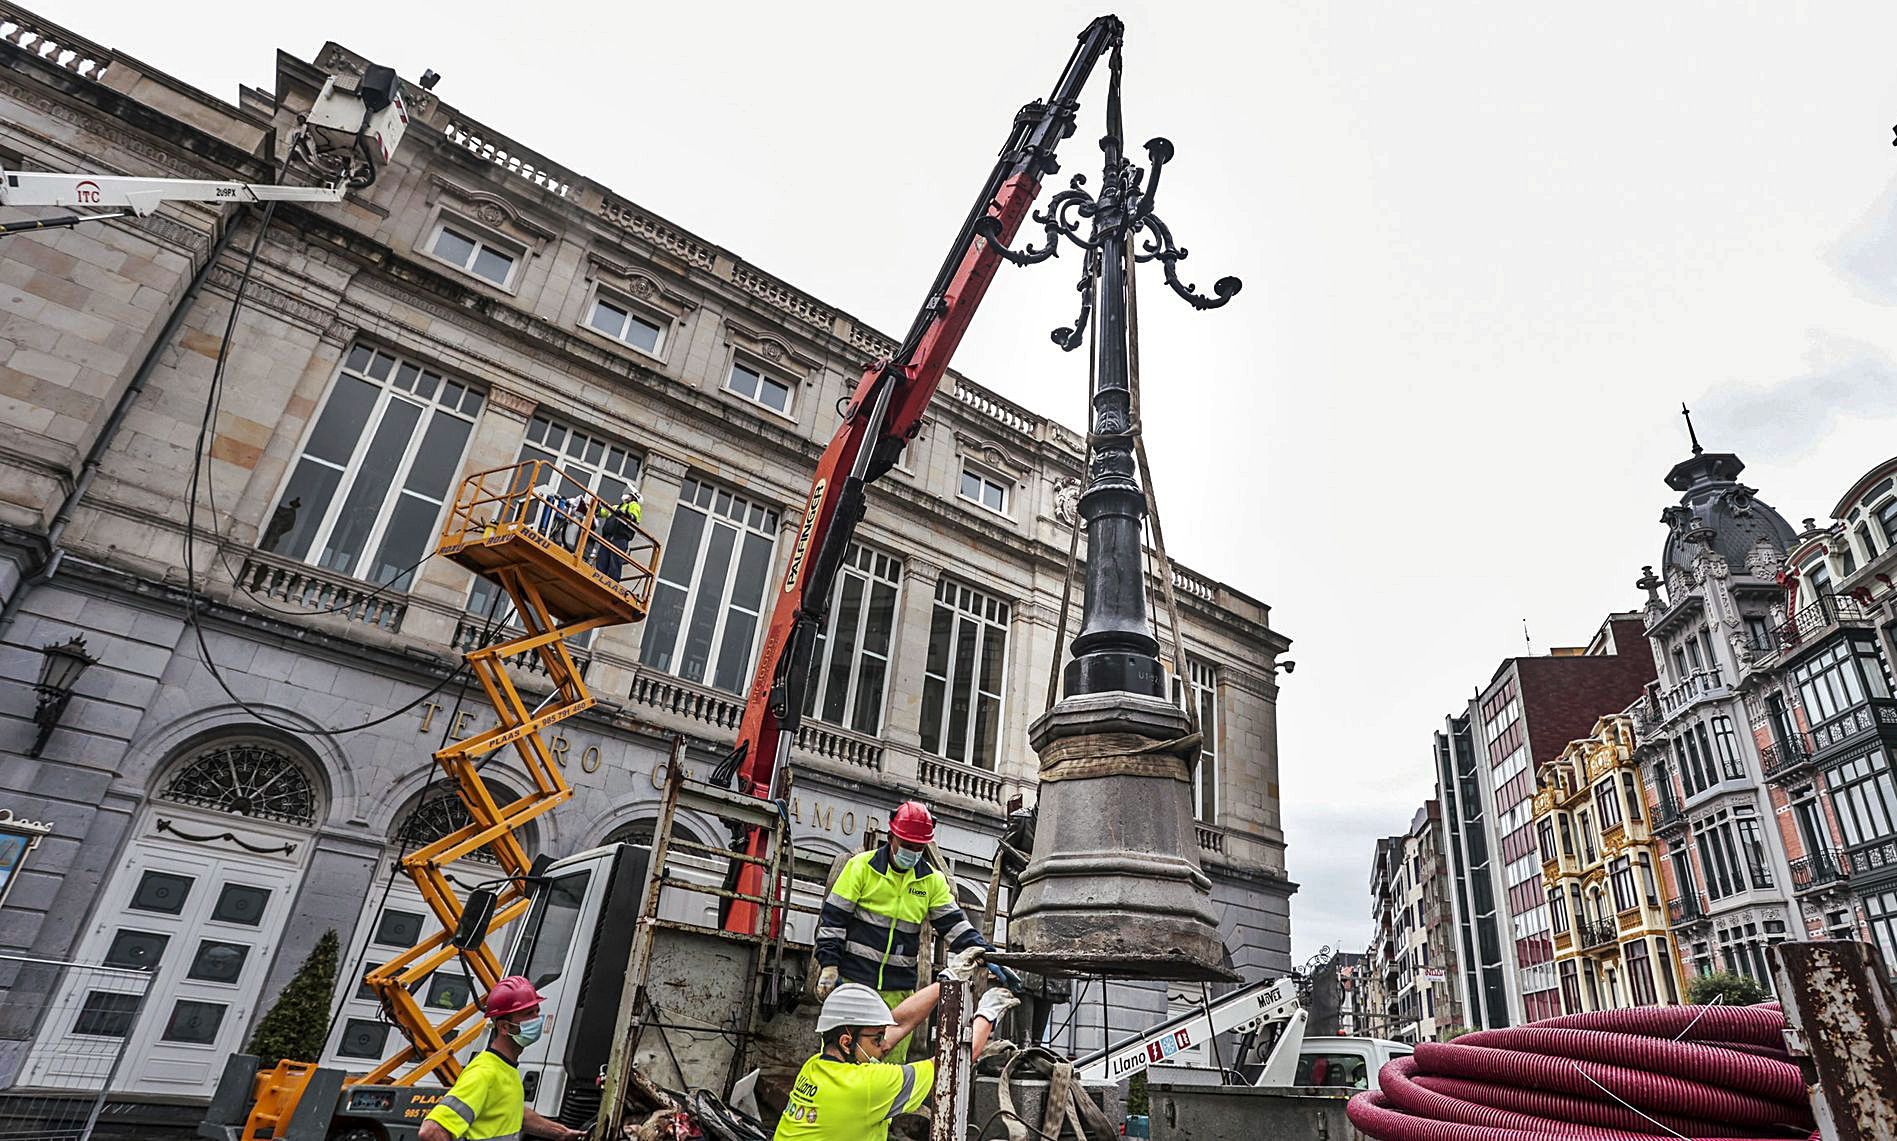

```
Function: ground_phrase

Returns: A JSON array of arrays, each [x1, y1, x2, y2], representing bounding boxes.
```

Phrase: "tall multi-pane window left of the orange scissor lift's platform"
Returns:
[[258, 346, 482, 589]]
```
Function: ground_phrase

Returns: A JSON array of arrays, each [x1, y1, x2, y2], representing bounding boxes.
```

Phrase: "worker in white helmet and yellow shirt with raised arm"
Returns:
[[774, 968, 1021, 1141]]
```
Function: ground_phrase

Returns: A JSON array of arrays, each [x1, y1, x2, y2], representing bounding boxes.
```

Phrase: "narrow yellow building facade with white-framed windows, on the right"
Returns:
[[1535, 714, 1685, 1014]]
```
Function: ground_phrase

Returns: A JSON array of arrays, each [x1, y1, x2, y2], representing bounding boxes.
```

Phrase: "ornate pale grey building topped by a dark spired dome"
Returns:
[[1631, 436, 1796, 989]]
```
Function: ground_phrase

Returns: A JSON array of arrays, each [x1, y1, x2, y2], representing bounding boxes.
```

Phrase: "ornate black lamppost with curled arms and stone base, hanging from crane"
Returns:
[[986, 51, 1241, 980]]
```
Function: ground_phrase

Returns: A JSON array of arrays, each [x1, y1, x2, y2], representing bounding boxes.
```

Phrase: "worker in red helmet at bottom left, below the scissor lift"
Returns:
[[415, 974, 586, 1141]]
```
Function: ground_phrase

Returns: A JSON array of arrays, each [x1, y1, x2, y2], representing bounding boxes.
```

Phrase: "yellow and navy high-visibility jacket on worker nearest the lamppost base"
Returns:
[[818, 847, 992, 991]]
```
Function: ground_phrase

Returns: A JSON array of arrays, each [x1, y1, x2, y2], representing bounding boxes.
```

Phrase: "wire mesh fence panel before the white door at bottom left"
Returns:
[[0, 955, 152, 1141]]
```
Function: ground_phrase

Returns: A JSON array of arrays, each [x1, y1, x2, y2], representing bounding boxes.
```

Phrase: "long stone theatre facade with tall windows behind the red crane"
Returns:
[[0, 17, 1296, 1101]]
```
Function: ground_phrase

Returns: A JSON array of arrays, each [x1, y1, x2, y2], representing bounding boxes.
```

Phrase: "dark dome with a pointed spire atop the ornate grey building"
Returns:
[[1660, 404, 1796, 583]]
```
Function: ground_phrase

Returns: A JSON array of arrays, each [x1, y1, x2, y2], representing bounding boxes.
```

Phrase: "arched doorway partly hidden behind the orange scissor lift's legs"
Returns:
[[322, 778, 539, 1073]]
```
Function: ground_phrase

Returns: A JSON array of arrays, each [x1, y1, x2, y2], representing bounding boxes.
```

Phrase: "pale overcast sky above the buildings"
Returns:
[[42, 0, 1897, 957]]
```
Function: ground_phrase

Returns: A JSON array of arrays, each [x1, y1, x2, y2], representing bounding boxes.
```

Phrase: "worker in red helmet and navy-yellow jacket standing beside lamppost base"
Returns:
[[816, 801, 994, 1063]]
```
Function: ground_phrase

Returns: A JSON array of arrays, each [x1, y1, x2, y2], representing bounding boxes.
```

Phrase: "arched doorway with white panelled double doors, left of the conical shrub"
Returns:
[[21, 733, 322, 1097]]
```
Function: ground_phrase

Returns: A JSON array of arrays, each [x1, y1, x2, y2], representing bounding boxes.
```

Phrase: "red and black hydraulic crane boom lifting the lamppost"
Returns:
[[725, 15, 1123, 932]]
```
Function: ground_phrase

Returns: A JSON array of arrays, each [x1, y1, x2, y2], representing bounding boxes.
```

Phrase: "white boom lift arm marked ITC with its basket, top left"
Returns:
[[0, 66, 415, 237]]
